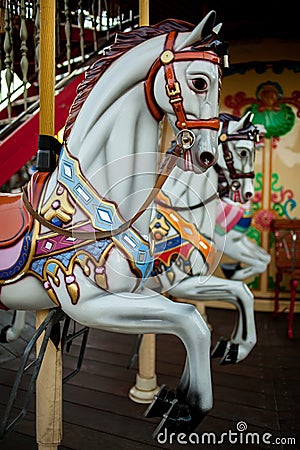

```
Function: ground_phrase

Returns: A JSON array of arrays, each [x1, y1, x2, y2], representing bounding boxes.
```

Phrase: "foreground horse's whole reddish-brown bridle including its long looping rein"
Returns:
[[23, 31, 227, 240]]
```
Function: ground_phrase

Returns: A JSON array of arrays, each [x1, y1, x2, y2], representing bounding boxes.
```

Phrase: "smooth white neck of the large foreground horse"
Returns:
[[44, 85, 158, 239]]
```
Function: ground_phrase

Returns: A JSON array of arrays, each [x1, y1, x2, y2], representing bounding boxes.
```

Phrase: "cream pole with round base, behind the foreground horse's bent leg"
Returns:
[[129, 0, 159, 403]]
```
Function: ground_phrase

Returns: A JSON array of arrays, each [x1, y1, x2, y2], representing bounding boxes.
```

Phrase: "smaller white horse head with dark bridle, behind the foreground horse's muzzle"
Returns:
[[215, 112, 264, 203]]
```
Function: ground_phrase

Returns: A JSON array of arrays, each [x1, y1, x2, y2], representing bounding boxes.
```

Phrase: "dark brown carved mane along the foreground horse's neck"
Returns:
[[64, 19, 195, 141]]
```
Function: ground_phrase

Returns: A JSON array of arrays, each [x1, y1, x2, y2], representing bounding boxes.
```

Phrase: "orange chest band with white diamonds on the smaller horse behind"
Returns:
[[155, 191, 215, 268]]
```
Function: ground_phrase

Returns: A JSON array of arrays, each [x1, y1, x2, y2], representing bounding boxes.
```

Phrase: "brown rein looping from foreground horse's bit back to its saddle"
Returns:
[[23, 144, 183, 240]]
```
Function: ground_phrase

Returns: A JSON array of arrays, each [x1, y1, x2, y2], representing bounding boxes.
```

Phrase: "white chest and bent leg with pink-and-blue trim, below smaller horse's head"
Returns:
[[215, 198, 271, 281]]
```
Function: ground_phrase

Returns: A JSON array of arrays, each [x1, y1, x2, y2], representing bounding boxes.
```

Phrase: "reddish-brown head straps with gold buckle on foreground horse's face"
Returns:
[[145, 31, 220, 131]]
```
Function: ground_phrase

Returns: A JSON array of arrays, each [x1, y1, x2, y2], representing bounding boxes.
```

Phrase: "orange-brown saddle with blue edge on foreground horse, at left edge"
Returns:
[[0, 172, 49, 284]]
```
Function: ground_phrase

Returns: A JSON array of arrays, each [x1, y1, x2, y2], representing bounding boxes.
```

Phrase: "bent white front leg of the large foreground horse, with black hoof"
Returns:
[[61, 276, 212, 436]]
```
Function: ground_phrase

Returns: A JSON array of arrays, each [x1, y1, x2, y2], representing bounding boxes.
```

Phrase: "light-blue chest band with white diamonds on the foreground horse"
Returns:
[[57, 147, 154, 278]]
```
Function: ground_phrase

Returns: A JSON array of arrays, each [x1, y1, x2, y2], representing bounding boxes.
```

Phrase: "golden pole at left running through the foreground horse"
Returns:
[[36, 0, 62, 450]]
